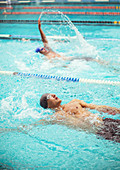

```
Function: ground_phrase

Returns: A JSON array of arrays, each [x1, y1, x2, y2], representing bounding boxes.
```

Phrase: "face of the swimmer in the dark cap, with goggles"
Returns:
[[47, 94, 62, 109]]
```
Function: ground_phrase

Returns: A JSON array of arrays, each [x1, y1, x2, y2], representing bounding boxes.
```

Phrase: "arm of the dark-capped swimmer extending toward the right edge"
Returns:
[[79, 100, 120, 115]]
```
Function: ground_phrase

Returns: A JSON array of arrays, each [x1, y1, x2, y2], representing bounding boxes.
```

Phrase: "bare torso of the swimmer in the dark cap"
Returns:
[[56, 99, 103, 131]]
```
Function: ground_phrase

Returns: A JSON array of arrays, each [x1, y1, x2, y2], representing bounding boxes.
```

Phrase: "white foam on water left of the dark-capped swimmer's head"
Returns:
[[0, 91, 50, 127]]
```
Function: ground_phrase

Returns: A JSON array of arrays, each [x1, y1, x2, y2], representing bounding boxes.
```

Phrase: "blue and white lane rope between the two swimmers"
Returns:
[[0, 71, 120, 86]]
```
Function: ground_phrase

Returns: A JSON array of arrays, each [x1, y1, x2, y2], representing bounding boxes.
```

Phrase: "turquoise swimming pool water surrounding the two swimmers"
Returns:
[[0, 2, 120, 169]]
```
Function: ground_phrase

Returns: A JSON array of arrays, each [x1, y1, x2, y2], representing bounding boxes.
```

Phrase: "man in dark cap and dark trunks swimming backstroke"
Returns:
[[38, 93, 120, 142]]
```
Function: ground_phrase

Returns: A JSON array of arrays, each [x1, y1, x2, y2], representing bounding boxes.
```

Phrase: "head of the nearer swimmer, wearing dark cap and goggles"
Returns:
[[40, 93, 62, 109]]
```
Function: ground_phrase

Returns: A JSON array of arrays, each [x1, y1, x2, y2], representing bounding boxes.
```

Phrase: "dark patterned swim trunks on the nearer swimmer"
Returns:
[[97, 118, 120, 143]]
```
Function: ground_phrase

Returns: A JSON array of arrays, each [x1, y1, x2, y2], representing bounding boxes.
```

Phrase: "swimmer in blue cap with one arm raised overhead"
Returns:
[[35, 18, 108, 65]]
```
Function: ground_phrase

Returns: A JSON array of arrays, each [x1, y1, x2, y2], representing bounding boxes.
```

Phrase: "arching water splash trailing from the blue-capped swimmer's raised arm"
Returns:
[[39, 10, 99, 58]]
